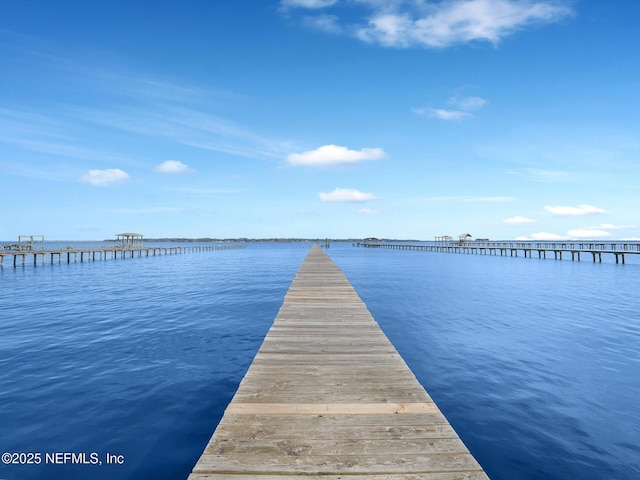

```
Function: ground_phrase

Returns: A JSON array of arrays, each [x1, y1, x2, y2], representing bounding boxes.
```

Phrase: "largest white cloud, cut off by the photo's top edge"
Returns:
[[356, 0, 571, 48]]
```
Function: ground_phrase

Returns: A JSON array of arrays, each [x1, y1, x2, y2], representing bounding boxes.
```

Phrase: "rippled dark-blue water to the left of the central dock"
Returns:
[[0, 246, 308, 480]]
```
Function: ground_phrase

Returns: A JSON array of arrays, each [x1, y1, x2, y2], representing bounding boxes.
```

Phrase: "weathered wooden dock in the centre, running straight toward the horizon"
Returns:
[[189, 246, 488, 480]]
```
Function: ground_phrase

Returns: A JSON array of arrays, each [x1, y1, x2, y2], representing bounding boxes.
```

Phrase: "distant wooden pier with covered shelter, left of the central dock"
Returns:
[[0, 244, 246, 267]]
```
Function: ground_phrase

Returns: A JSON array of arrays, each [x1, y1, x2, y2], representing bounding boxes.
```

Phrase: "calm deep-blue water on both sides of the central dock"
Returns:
[[0, 243, 640, 480]]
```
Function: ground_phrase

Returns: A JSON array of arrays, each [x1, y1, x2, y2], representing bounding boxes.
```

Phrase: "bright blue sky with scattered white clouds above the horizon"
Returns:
[[0, 0, 640, 240]]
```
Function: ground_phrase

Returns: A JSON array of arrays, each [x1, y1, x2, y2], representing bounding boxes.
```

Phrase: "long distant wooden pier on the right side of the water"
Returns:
[[353, 241, 640, 264]]
